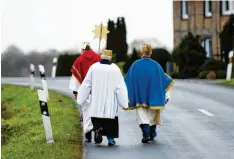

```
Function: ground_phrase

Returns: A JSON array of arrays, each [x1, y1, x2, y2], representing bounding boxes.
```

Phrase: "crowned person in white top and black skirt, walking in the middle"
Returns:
[[77, 50, 128, 146]]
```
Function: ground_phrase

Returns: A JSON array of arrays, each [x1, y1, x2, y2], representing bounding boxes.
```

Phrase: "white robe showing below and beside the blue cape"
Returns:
[[136, 91, 171, 126]]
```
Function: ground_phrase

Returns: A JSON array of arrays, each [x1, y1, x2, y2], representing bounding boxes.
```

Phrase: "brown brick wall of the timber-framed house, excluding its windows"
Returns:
[[173, 1, 229, 59]]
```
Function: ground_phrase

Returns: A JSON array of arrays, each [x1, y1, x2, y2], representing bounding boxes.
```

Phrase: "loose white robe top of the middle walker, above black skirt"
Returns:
[[77, 62, 128, 119]]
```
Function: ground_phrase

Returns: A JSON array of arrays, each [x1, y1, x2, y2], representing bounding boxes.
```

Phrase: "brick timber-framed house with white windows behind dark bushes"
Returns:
[[173, 0, 234, 59]]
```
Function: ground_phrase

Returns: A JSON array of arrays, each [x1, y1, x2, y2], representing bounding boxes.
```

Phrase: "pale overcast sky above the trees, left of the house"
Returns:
[[0, 0, 173, 51]]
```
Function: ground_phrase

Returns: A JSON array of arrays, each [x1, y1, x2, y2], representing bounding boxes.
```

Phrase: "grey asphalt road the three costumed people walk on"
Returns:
[[2, 78, 234, 159]]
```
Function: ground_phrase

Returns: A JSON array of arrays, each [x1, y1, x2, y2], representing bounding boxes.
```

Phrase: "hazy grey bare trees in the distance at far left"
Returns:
[[1, 45, 59, 77]]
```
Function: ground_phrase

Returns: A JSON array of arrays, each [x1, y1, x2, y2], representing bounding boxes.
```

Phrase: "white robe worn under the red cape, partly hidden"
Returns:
[[69, 75, 93, 133]]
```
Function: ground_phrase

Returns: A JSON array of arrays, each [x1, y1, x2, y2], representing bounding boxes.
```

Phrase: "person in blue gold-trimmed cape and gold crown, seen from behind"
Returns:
[[125, 44, 174, 143]]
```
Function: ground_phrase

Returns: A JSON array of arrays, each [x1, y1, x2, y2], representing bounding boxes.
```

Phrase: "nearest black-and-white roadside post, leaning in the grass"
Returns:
[[37, 89, 54, 143]]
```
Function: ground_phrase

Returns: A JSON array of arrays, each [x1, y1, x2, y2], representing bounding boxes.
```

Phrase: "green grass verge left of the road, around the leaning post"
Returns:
[[1, 85, 83, 159]]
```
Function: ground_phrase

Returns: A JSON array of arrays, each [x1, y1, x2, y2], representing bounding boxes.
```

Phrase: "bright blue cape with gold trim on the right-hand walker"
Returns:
[[124, 58, 174, 110]]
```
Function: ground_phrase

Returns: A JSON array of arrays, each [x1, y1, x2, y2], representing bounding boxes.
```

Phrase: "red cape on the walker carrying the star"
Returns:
[[71, 50, 101, 84]]
